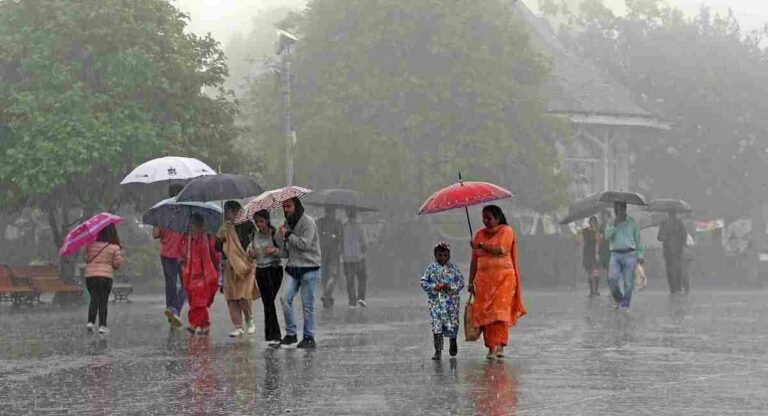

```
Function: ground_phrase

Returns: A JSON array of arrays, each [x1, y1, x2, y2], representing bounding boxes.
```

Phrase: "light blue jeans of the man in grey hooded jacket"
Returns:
[[283, 270, 320, 338]]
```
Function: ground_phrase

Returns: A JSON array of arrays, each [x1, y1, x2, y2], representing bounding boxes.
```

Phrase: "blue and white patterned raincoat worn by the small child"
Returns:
[[421, 262, 464, 338]]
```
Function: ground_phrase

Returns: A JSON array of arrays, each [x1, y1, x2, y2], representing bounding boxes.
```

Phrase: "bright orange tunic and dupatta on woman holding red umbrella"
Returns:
[[472, 225, 527, 327]]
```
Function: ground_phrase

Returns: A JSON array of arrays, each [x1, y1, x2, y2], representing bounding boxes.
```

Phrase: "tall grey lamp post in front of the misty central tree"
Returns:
[[276, 29, 298, 186]]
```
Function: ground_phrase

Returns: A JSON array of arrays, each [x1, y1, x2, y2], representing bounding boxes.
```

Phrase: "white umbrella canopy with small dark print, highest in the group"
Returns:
[[120, 156, 216, 185]]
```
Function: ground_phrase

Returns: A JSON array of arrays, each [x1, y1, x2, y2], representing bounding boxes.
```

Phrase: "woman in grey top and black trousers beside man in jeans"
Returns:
[[248, 210, 283, 345]]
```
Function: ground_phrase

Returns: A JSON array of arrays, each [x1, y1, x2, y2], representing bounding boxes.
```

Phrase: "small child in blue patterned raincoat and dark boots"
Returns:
[[421, 242, 464, 360]]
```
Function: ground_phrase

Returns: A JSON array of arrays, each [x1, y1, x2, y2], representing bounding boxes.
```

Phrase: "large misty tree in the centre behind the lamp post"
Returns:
[[243, 0, 565, 211]]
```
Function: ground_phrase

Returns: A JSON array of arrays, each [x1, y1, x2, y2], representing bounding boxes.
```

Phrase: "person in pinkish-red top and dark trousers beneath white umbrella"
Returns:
[[152, 184, 186, 328]]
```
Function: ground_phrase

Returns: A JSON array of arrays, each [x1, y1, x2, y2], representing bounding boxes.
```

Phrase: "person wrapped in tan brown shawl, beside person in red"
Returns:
[[216, 201, 256, 338]]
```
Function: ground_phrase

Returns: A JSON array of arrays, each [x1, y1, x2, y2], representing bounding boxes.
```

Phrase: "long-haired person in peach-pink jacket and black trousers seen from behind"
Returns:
[[84, 224, 123, 334]]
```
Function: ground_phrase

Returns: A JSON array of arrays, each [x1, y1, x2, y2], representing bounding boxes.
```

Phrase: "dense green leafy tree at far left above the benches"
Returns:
[[0, 0, 236, 260]]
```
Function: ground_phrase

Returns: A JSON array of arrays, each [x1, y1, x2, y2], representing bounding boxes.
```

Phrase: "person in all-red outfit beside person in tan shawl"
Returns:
[[181, 214, 220, 335]]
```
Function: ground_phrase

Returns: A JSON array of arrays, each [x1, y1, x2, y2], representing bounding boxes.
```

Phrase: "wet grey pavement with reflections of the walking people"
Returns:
[[0, 291, 768, 415]]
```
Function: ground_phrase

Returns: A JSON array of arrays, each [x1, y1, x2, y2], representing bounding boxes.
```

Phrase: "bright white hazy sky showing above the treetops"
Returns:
[[175, 0, 768, 43]]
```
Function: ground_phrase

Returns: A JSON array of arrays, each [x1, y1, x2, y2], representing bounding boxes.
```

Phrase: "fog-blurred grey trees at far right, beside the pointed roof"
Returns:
[[552, 0, 768, 215]]
